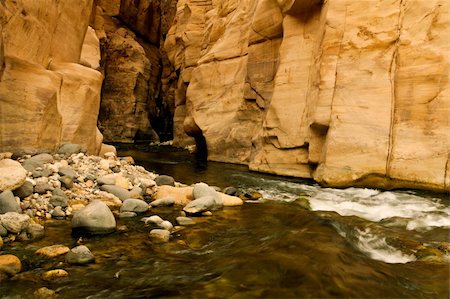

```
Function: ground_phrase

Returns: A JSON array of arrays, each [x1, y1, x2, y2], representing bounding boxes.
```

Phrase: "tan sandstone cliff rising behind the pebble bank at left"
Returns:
[[0, 0, 102, 153]]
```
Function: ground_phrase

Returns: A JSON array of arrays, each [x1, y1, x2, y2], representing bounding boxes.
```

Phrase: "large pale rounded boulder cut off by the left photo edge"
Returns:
[[0, 159, 27, 191]]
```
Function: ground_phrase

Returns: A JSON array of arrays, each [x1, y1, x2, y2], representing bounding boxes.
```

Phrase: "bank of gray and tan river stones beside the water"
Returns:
[[0, 144, 246, 288]]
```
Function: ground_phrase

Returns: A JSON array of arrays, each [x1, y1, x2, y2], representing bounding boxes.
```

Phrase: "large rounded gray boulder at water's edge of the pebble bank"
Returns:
[[72, 200, 116, 234]]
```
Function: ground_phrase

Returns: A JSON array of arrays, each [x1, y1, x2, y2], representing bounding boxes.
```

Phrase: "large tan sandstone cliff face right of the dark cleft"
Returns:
[[165, 0, 450, 191]]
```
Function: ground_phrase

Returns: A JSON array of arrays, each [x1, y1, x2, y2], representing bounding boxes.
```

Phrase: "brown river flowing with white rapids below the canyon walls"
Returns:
[[0, 146, 450, 298]]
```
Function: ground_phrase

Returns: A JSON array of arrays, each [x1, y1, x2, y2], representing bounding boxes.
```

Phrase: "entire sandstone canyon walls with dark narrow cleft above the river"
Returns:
[[0, 0, 450, 191]]
